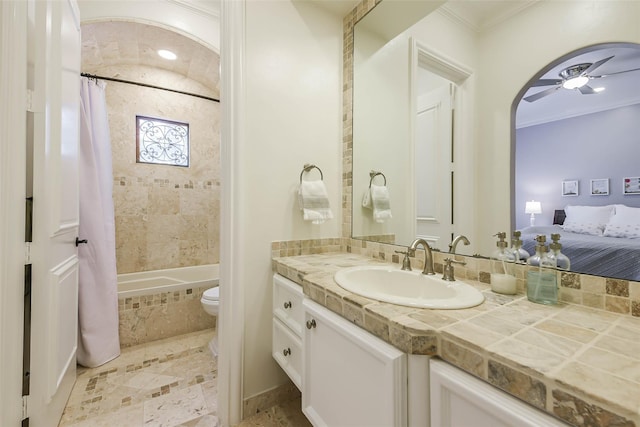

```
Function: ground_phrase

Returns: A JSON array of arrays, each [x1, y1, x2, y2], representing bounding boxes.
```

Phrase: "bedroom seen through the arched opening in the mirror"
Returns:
[[513, 43, 640, 281]]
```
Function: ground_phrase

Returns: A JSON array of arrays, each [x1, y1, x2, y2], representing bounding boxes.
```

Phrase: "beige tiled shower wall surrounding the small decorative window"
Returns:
[[97, 66, 220, 273]]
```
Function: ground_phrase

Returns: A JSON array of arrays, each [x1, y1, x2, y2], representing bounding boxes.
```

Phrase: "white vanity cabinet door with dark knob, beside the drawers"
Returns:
[[302, 299, 407, 427]]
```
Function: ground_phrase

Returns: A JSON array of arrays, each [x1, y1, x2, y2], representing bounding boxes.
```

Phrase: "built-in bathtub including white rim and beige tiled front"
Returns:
[[118, 264, 219, 348]]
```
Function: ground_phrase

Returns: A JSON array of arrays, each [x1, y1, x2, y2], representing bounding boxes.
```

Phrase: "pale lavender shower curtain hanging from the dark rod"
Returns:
[[77, 77, 120, 367]]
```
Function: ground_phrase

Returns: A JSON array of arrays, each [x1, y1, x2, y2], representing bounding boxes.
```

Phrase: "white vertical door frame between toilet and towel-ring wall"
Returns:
[[218, 0, 246, 427]]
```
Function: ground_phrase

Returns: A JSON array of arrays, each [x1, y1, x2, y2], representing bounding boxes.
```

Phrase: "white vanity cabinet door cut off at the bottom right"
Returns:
[[429, 359, 567, 427]]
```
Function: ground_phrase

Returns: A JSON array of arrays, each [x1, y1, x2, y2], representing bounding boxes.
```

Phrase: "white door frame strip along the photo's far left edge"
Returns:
[[0, 1, 27, 426]]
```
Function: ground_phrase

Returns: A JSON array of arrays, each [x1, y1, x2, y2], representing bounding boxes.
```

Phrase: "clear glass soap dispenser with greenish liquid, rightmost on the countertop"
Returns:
[[527, 235, 558, 304]]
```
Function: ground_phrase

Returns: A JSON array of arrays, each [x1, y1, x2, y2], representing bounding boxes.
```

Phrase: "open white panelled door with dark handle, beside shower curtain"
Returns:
[[27, 0, 80, 427]]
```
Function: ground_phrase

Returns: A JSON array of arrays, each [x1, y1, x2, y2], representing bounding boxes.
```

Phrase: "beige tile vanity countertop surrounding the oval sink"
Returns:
[[273, 253, 640, 427]]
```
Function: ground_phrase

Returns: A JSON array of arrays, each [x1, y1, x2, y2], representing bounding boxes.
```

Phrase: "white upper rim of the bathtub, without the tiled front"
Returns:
[[118, 264, 220, 298]]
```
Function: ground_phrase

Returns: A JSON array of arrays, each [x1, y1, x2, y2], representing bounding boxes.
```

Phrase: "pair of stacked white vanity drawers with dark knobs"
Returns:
[[271, 274, 304, 390]]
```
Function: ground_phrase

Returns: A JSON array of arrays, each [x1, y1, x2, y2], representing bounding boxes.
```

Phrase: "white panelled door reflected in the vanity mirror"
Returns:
[[414, 83, 455, 250]]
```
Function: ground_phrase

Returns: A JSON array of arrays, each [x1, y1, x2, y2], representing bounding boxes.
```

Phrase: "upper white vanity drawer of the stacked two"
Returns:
[[273, 274, 304, 337]]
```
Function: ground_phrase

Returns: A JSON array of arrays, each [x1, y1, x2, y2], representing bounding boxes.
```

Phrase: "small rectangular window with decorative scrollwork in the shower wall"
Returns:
[[136, 116, 189, 167]]
